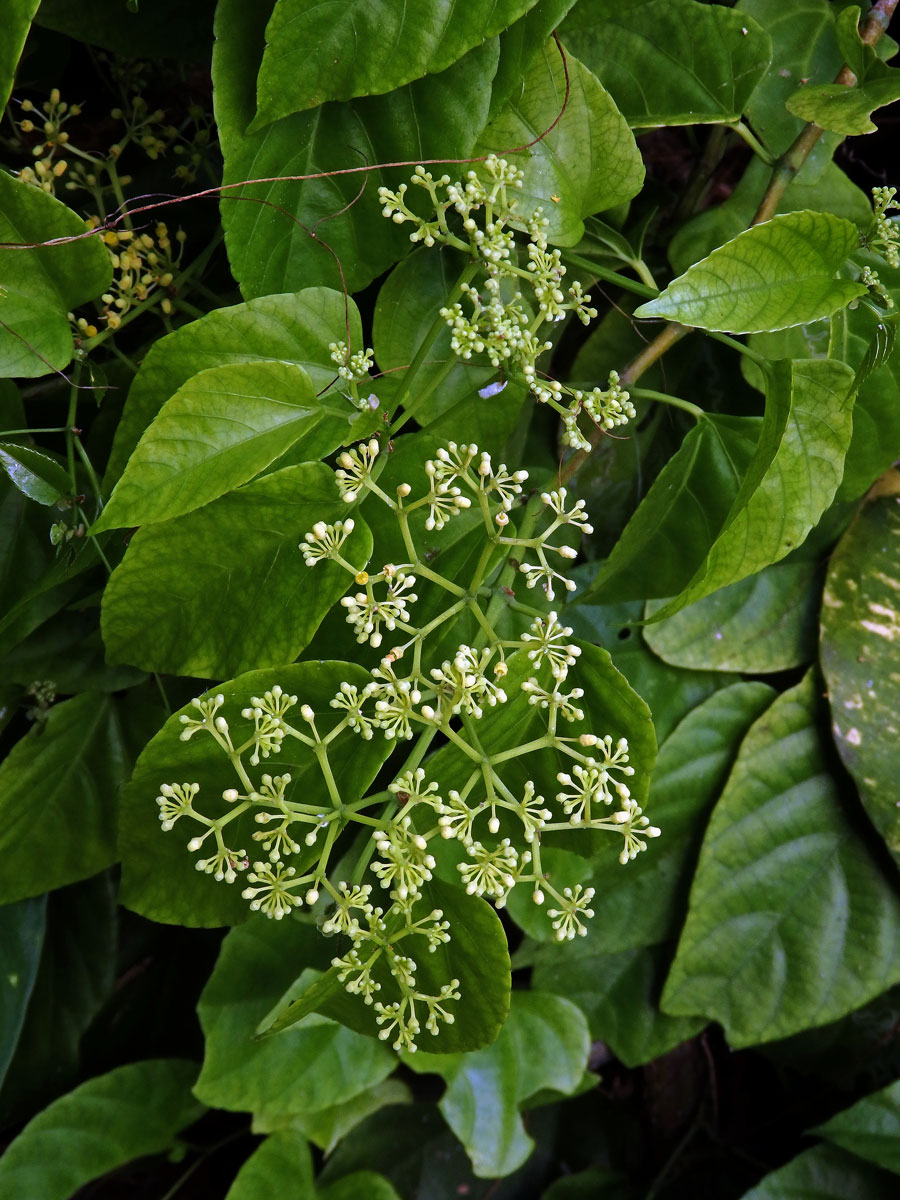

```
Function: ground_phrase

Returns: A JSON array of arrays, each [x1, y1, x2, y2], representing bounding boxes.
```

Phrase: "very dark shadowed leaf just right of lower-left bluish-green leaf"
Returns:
[[0, 871, 118, 1123]]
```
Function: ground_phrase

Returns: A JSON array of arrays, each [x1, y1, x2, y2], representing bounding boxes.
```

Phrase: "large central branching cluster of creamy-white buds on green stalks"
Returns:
[[157, 438, 659, 1050]]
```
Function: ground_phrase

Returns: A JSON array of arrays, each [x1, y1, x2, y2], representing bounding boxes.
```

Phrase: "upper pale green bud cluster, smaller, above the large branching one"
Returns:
[[378, 155, 635, 450]]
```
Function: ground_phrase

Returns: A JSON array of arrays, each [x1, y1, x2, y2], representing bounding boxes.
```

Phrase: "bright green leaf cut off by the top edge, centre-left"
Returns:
[[248, 0, 535, 124]]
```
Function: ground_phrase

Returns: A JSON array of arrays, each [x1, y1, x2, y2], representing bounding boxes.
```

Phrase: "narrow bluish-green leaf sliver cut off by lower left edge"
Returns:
[[0, 896, 47, 1086]]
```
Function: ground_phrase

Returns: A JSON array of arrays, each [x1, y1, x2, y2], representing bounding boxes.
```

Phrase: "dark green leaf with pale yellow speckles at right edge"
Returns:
[[822, 482, 900, 862]]
